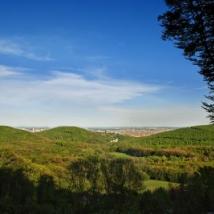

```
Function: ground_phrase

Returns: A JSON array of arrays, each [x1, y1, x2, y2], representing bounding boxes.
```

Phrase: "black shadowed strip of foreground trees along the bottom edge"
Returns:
[[0, 167, 214, 214]]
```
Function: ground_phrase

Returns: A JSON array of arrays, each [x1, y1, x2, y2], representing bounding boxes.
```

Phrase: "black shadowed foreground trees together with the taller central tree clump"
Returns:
[[0, 163, 214, 214]]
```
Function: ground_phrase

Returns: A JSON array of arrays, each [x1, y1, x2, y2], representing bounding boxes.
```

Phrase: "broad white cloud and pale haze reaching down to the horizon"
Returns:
[[0, 66, 208, 126]]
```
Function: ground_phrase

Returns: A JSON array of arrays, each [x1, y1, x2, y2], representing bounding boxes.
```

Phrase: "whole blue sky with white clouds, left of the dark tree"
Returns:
[[0, 0, 208, 127]]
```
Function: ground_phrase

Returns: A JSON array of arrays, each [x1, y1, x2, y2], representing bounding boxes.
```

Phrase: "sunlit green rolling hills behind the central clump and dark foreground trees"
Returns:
[[0, 125, 214, 185]]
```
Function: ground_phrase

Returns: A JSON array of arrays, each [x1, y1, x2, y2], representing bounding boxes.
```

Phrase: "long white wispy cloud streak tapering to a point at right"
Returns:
[[0, 68, 160, 105]]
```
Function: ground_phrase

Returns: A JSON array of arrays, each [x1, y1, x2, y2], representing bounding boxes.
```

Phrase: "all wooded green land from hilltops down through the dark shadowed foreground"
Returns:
[[0, 125, 214, 214]]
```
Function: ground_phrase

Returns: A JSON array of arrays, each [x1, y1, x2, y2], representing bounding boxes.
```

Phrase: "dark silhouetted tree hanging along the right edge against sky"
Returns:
[[158, 0, 214, 123]]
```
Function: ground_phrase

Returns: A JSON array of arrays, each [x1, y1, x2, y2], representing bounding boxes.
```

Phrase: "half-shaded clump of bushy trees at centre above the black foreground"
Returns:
[[70, 156, 146, 194]]
